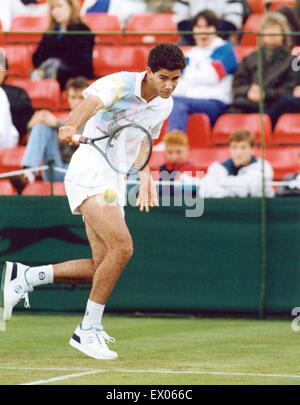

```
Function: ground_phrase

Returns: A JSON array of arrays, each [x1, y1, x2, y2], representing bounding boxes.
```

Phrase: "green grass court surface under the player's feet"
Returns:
[[0, 312, 300, 385]]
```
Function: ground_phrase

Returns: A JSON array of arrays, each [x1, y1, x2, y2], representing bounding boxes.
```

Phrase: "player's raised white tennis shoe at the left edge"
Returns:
[[0, 262, 33, 321]]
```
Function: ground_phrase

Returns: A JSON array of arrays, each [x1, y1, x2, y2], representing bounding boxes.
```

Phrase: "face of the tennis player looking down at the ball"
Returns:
[[147, 67, 181, 98]]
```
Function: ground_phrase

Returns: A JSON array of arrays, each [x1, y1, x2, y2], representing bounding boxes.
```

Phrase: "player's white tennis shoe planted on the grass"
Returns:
[[69, 324, 118, 360]]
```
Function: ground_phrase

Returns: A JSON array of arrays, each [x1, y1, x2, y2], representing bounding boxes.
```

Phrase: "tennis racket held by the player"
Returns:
[[73, 123, 153, 176]]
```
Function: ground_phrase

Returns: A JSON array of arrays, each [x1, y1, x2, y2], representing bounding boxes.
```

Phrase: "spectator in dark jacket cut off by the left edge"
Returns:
[[0, 59, 34, 142]]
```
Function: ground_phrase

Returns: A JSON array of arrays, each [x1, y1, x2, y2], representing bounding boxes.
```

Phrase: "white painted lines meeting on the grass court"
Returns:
[[6, 367, 300, 385]]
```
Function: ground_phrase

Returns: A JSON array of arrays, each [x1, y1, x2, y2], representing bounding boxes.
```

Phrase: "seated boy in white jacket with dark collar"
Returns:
[[203, 129, 274, 198]]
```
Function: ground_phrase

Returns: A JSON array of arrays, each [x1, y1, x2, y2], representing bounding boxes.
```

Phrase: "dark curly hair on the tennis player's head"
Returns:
[[147, 42, 186, 73]]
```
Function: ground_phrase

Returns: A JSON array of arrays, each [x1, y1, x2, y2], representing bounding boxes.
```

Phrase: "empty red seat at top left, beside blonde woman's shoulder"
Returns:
[[4, 16, 48, 43]]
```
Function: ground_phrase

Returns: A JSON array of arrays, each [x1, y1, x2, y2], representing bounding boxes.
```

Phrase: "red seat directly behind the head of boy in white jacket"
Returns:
[[211, 114, 272, 146]]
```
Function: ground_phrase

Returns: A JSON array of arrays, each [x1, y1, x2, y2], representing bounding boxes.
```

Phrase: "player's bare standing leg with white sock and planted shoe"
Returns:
[[70, 196, 132, 359]]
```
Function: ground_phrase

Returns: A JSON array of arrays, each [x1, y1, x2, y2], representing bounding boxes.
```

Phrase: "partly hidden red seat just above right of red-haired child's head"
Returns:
[[186, 114, 211, 149]]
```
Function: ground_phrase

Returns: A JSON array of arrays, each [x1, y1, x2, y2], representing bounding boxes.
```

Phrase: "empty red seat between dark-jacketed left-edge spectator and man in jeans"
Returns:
[[9, 79, 60, 111]]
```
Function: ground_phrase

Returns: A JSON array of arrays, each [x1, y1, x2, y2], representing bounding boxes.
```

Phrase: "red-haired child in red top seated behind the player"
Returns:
[[159, 130, 197, 196]]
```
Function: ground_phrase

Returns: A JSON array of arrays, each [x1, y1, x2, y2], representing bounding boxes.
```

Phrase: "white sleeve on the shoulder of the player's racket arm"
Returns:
[[82, 73, 125, 108]]
